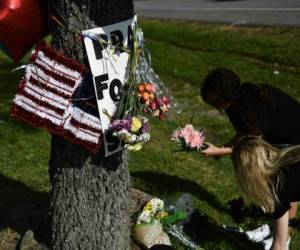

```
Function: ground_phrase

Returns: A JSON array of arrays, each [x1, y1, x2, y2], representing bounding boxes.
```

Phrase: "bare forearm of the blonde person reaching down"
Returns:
[[271, 211, 289, 250]]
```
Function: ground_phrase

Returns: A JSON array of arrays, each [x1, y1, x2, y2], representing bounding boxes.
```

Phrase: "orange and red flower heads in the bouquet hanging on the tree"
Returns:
[[137, 83, 170, 120]]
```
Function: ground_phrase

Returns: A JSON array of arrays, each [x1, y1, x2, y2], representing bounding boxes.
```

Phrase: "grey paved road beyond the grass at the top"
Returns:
[[135, 0, 300, 27]]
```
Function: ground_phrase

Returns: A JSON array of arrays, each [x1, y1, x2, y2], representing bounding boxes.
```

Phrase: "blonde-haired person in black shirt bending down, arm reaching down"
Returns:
[[231, 136, 300, 250]]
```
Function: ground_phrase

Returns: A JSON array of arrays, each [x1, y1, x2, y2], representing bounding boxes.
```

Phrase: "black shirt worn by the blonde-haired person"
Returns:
[[273, 162, 300, 219]]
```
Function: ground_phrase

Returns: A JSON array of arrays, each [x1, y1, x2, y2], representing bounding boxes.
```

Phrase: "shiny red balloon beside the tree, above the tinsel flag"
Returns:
[[0, 0, 47, 61]]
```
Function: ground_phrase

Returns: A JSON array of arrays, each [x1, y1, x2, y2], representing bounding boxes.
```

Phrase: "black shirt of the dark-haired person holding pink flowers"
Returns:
[[225, 84, 300, 145]]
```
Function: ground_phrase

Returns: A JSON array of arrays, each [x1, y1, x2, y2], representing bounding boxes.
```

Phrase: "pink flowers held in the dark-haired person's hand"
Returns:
[[171, 124, 206, 151]]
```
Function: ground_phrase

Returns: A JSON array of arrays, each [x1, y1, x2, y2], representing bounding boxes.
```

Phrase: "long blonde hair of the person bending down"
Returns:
[[231, 136, 300, 213]]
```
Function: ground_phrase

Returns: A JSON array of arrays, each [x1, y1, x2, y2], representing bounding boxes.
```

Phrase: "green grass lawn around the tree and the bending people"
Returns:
[[0, 19, 300, 250]]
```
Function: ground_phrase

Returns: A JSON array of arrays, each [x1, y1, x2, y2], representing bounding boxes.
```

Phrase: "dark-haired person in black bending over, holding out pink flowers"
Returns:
[[200, 68, 300, 222]]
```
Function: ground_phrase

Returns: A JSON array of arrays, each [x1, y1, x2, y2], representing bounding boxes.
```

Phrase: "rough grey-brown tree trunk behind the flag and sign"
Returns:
[[49, 0, 133, 250]]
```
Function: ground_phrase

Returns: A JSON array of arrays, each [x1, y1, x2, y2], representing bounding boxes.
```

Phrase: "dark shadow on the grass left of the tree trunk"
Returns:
[[0, 174, 49, 243]]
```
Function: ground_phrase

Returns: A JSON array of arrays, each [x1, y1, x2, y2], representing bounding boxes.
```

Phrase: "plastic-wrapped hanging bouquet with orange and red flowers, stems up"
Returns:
[[116, 26, 173, 120]]
